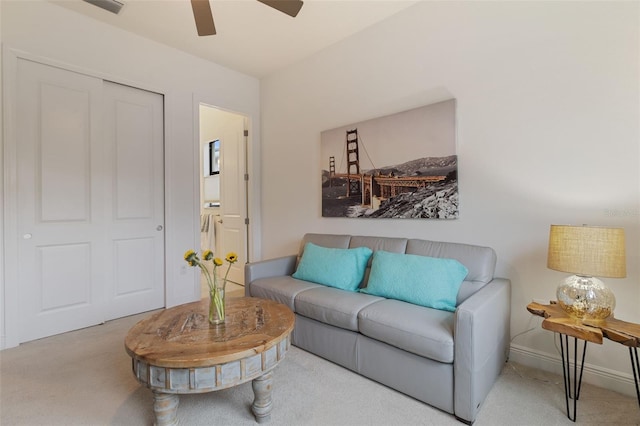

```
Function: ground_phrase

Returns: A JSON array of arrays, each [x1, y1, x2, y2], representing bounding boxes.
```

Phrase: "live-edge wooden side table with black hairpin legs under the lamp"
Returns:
[[527, 302, 640, 422]]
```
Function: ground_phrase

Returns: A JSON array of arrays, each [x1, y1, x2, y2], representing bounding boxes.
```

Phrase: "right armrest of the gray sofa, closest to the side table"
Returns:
[[454, 278, 511, 423]]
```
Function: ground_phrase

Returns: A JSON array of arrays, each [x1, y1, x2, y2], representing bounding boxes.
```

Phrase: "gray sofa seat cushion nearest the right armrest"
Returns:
[[358, 299, 455, 363]]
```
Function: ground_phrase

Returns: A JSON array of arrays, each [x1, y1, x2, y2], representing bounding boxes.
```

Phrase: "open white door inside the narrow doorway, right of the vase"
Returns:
[[220, 113, 247, 285]]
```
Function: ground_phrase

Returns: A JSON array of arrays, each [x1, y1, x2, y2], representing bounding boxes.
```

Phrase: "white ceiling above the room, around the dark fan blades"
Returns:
[[51, 0, 417, 78]]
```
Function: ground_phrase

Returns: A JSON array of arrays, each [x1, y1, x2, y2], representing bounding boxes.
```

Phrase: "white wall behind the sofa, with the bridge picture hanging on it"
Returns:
[[261, 2, 640, 393]]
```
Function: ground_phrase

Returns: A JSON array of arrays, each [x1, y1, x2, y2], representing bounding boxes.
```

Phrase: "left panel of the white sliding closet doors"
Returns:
[[16, 59, 107, 342]]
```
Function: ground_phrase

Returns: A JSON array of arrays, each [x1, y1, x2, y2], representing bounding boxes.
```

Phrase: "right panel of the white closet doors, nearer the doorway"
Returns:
[[104, 82, 165, 319]]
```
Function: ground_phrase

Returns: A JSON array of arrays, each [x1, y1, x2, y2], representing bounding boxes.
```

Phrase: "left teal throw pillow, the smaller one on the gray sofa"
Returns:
[[293, 243, 372, 291]]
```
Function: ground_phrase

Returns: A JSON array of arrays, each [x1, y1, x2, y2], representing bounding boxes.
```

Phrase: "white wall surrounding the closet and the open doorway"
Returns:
[[0, 0, 260, 345]]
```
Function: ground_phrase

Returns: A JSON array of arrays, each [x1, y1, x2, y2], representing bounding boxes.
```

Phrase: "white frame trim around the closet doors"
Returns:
[[0, 46, 171, 350]]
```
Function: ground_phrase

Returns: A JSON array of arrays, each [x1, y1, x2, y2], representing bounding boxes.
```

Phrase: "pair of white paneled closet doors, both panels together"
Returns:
[[15, 59, 164, 342]]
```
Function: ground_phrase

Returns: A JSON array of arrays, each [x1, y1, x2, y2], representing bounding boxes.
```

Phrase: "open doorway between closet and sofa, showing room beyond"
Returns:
[[199, 103, 249, 297]]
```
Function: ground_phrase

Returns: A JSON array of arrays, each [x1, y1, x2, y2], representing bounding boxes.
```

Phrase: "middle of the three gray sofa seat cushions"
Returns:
[[295, 286, 384, 331]]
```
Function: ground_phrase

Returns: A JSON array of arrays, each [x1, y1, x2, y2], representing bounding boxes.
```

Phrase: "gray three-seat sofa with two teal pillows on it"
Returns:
[[245, 234, 511, 424]]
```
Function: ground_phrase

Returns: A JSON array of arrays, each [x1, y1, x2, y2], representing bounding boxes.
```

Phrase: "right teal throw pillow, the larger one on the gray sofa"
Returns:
[[360, 250, 469, 312]]
